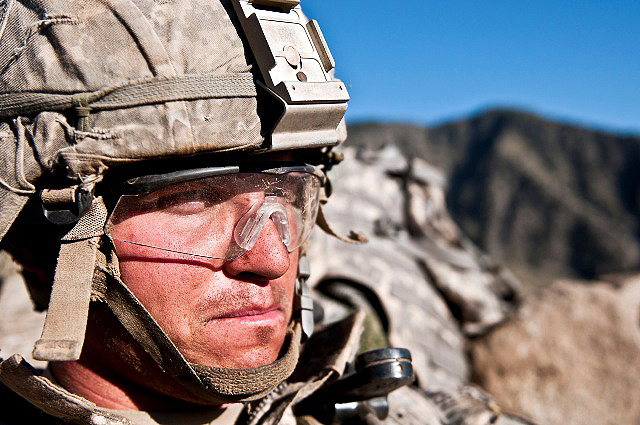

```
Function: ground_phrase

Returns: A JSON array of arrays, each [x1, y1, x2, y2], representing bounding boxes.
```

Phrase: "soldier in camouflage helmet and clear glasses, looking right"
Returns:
[[0, 0, 532, 424]]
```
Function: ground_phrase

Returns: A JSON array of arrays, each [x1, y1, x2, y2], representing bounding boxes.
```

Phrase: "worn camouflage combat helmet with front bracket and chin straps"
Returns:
[[0, 0, 356, 402]]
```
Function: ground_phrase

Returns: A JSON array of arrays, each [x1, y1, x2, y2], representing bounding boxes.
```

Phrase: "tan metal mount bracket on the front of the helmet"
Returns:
[[232, 0, 349, 150]]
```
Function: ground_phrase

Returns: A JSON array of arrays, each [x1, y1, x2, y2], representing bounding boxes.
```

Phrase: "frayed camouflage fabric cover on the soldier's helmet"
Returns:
[[0, 0, 348, 237]]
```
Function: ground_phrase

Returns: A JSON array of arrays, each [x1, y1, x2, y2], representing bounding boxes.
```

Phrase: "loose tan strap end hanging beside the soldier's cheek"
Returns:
[[33, 198, 107, 361]]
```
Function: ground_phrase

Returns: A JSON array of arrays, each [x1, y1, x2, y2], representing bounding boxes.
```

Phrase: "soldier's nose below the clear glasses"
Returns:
[[223, 220, 290, 280]]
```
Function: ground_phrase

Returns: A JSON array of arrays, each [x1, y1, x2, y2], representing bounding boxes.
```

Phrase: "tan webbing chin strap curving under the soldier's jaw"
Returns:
[[103, 262, 301, 404]]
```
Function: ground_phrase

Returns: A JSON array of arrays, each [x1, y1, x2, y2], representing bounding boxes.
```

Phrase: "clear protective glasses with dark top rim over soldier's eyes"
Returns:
[[105, 165, 325, 261]]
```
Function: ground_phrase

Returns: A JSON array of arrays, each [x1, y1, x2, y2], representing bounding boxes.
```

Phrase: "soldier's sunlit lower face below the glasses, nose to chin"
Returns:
[[112, 214, 298, 369]]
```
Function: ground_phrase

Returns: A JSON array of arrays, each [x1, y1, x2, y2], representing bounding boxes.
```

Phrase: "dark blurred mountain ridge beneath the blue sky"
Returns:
[[347, 110, 640, 285]]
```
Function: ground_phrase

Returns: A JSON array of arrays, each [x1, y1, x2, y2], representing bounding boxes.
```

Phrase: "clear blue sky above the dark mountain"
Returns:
[[302, 0, 640, 134]]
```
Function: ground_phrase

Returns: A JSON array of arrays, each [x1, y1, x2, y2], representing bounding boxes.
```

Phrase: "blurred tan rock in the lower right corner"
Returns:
[[471, 276, 640, 425]]
